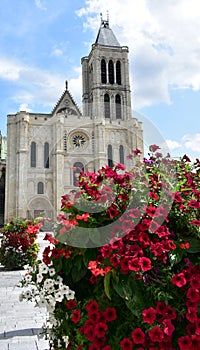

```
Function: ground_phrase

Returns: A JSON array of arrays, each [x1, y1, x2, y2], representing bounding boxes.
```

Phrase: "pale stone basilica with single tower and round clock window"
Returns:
[[4, 19, 143, 222]]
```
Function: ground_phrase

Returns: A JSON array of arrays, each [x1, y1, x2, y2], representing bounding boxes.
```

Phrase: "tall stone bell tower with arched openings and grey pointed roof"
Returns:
[[81, 17, 132, 121]]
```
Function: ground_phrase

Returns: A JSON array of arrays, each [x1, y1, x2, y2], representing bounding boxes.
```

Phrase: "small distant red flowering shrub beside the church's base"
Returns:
[[0, 218, 40, 270]]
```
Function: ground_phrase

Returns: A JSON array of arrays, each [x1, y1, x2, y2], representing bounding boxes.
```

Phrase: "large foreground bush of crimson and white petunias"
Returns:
[[19, 145, 200, 350]]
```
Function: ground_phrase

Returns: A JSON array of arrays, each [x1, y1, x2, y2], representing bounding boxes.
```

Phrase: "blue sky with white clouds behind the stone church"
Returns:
[[0, 0, 200, 159]]
